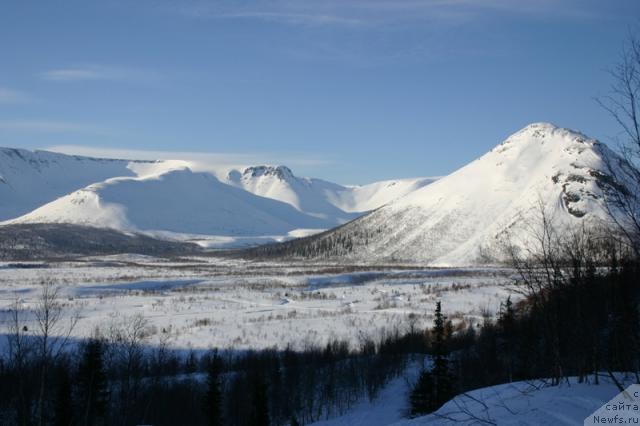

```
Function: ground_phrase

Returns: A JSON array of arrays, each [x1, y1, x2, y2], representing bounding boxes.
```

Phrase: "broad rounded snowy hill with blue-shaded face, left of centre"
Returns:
[[6, 168, 340, 236]]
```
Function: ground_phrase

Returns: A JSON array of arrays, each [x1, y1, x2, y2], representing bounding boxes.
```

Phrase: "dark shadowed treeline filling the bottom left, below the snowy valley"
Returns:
[[0, 306, 424, 426]]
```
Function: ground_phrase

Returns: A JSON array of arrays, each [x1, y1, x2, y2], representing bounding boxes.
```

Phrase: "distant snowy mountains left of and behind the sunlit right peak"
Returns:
[[0, 149, 433, 244]]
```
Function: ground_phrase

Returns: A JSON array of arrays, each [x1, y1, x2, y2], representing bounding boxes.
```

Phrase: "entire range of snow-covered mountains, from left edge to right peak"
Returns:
[[10, 123, 615, 265]]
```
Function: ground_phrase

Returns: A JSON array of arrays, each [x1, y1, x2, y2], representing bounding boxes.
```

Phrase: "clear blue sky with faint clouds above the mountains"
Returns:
[[0, 0, 640, 183]]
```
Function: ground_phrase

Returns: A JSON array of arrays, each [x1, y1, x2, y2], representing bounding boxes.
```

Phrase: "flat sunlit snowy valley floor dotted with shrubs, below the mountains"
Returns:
[[0, 256, 518, 349]]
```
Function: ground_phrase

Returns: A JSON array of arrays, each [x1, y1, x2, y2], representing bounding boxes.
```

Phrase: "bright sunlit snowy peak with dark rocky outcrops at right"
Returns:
[[249, 123, 614, 265]]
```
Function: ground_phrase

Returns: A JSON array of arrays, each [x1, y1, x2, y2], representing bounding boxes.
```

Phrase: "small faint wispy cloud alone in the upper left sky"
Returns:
[[40, 64, 160, 82]]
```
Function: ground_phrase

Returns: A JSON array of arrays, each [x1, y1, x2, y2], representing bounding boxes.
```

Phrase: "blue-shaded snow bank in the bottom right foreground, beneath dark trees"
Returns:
[[316, 372, 633, 426]]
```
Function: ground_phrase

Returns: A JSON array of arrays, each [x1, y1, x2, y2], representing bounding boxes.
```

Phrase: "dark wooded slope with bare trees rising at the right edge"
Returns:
[[410, 221, 640, 415]]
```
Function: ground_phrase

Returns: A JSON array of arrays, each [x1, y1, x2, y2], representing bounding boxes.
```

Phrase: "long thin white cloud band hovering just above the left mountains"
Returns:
[[44, 145, 333, 167]]
